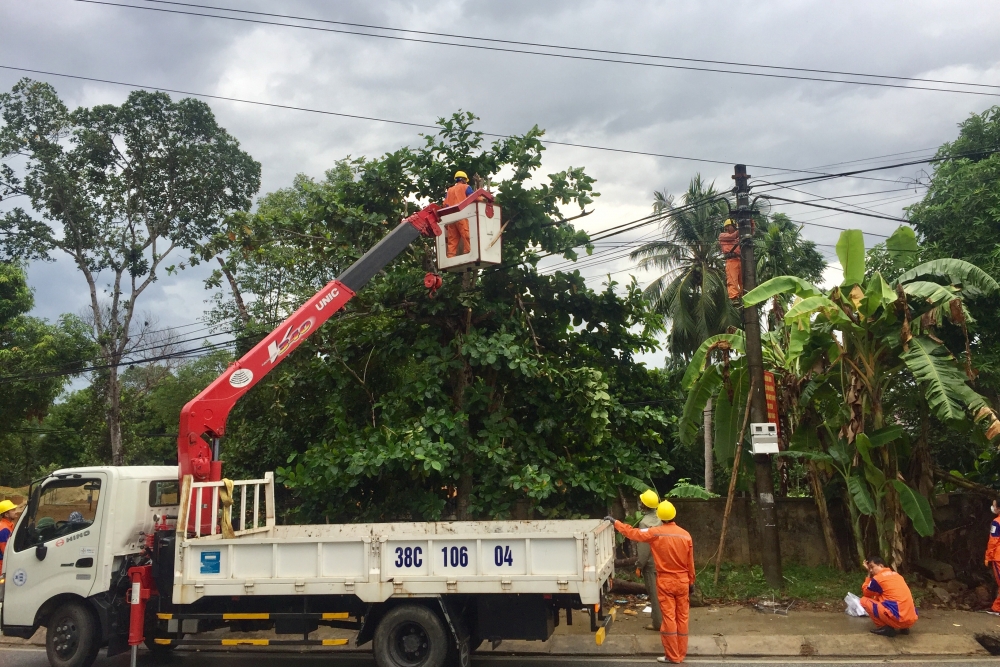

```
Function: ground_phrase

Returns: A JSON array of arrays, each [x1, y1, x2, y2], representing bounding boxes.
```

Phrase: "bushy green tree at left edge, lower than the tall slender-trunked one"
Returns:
[[0, 262, 94, 485]]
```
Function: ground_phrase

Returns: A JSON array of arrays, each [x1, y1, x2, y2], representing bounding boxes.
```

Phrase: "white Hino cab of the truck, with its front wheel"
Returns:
[[0, 466, 178, 664]]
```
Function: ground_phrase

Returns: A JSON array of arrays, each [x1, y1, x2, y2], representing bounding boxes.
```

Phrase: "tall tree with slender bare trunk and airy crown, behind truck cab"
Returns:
[[0, 79, 260, 465]]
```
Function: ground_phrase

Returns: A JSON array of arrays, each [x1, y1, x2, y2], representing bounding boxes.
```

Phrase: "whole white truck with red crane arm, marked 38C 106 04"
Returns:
[[0, 190, 615, 667]]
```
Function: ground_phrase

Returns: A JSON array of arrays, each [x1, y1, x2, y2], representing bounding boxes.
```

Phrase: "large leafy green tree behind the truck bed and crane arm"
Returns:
[[207, 114, 672, 521]]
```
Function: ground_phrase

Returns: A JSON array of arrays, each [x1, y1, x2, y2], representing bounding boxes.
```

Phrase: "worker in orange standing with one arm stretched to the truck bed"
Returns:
[[605, 500, 695, 663]]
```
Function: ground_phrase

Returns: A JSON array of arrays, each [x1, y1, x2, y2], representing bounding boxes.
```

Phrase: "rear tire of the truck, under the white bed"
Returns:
[[373, 604, 450, 667]]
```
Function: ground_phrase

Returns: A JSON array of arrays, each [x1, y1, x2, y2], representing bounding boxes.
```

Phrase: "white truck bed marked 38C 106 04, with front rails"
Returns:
[[173, 476, 615, 604]]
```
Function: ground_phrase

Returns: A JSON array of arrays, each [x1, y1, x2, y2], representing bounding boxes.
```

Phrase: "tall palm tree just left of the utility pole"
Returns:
[[629, 174, 740, 491]]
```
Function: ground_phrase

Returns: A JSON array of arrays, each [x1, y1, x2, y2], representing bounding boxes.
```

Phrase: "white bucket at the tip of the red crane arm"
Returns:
[[437, 190, 503, 272]]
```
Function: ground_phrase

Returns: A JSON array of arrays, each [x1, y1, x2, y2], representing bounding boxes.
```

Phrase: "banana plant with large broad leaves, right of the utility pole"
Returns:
[[743, 226, 1000, 565]]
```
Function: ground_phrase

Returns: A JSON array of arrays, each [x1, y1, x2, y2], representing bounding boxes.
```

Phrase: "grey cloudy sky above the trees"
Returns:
[[0, 0, 1000, 368]]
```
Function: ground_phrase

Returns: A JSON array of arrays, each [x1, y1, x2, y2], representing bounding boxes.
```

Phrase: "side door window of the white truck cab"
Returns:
[[14, 479, 101, 551]]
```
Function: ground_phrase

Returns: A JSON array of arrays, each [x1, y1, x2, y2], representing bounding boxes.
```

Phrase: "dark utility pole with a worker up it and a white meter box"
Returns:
[[733, 164, 784, 588]]
